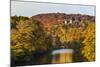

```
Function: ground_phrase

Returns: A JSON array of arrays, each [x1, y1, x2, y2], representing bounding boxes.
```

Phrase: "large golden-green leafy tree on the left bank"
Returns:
[[11, 20, 47, 61]]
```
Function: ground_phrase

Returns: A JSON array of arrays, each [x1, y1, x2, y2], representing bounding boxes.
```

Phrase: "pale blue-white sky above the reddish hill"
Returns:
[[11, 1, 95, 17]]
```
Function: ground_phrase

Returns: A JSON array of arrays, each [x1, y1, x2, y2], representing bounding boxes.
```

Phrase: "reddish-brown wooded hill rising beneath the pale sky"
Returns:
[[31, 13, 95, 24]]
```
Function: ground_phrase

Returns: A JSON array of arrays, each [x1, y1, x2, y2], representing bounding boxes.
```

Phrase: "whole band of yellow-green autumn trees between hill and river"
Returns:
[[11, 16, 95, 64]]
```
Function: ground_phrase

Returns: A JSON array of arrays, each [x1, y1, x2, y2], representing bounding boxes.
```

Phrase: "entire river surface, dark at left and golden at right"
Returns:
[[12, 49, 73, 66]]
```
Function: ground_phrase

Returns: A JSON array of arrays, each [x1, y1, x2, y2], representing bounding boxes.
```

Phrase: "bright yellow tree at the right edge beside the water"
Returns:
[[82, 23, 95, 61]]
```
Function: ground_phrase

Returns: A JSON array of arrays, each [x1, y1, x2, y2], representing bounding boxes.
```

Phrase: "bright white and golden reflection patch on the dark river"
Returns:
[[52, 49, 73, 64]]
